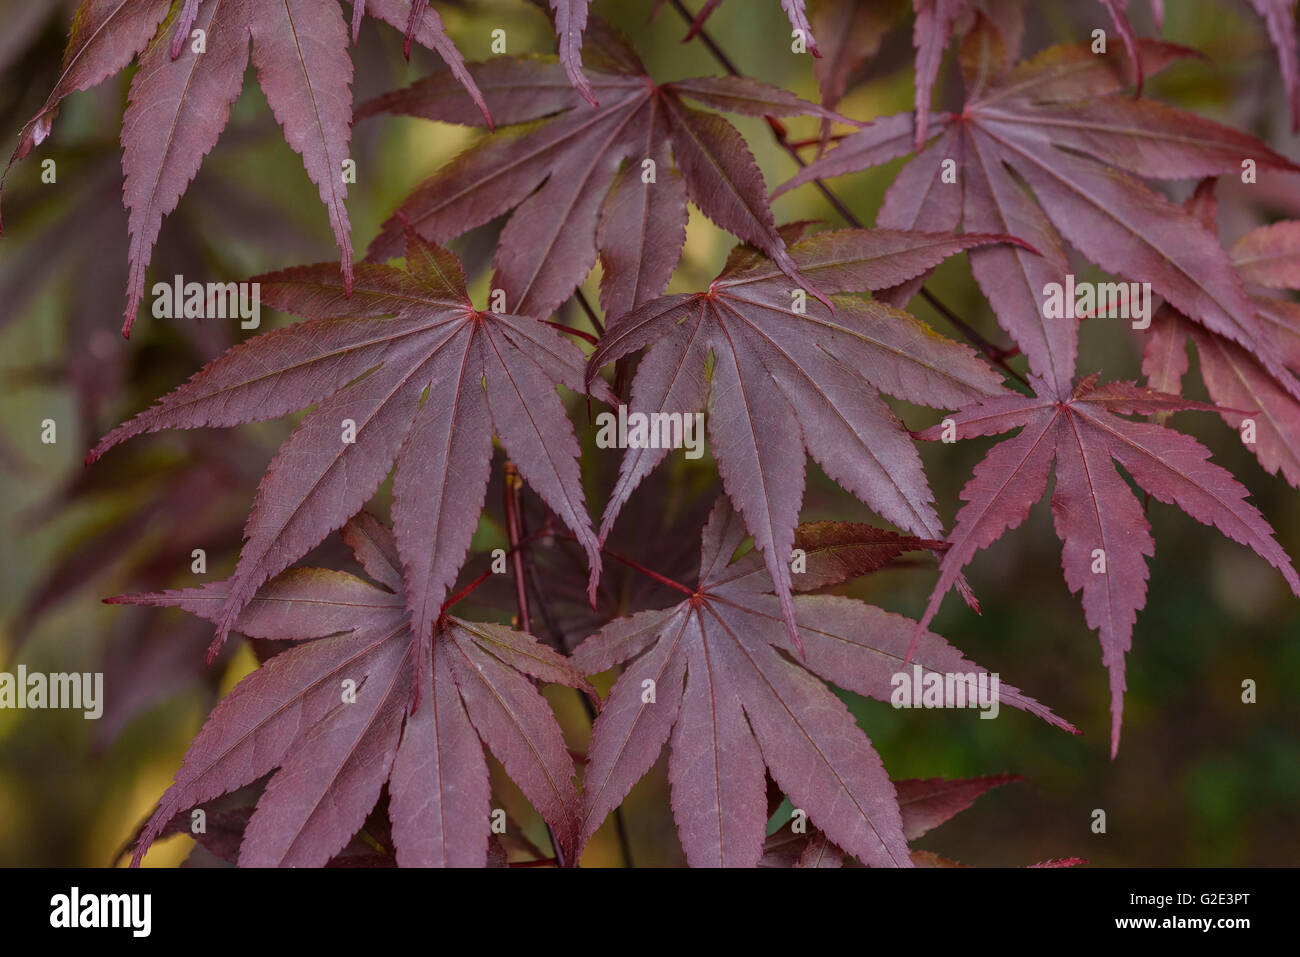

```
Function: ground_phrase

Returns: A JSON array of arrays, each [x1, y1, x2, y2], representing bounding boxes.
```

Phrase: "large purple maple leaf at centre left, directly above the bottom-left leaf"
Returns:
[[87, 234, 612, 670]]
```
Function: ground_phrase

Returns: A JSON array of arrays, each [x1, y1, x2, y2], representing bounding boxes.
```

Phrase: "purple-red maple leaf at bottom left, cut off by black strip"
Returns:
[[111, 518, 594, 867]]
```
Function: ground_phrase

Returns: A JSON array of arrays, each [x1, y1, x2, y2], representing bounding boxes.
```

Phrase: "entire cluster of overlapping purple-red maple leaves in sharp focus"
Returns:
[[45, 0, 1300, 865]]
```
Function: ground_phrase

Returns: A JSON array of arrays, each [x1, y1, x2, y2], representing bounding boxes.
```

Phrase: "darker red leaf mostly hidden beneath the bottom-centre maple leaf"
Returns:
[[758, 774, 1087, 867]]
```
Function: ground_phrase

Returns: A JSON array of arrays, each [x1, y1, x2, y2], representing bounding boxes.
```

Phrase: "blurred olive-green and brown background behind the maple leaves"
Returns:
[[0, 0, 1300, 866]]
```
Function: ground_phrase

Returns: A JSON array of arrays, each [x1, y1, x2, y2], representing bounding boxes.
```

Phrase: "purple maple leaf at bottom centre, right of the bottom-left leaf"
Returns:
[[572, 498, 1075, 867]]
